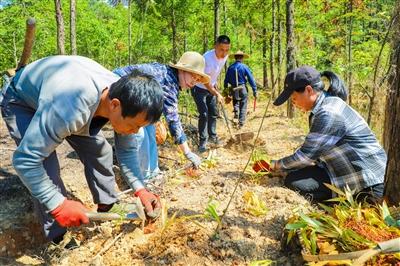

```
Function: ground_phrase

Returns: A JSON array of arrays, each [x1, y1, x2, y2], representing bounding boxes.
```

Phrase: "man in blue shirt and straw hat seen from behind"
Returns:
[[224, 50, 257, 128]]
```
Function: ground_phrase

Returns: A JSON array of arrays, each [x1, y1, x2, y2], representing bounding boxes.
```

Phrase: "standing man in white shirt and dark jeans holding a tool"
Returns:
[[192, 35, 231, 152]]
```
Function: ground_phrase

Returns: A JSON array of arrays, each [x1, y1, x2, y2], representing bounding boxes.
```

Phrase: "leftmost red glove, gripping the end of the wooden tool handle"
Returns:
[[50, 199, 89, 227]]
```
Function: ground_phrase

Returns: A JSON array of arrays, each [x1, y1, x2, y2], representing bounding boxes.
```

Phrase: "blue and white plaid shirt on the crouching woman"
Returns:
[[278, 93, 387, 192]]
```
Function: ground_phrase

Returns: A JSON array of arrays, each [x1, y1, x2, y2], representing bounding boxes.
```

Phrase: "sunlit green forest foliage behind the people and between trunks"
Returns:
[[0, 0, 395, 135]]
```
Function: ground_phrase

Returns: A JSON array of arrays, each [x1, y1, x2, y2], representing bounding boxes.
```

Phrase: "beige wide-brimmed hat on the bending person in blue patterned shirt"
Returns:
[[169, 52, 210, 84]]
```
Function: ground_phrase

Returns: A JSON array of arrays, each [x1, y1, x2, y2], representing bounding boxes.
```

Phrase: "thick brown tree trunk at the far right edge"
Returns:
[[383, 1, 400, 205]]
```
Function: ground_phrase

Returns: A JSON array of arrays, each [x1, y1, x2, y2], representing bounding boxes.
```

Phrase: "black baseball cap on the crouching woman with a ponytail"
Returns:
[[274, 66, 321, 106]]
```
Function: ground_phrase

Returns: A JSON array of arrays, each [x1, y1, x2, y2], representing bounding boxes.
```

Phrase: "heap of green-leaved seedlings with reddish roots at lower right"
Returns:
[[285, 185, 400, 258]]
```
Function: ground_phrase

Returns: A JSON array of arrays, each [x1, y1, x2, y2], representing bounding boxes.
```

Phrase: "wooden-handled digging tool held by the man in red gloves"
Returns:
[[86, 198, 146, 223]]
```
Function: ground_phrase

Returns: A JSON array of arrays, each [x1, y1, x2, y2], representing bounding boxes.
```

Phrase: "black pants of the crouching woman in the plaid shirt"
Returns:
[[285, 166, 384, 203]]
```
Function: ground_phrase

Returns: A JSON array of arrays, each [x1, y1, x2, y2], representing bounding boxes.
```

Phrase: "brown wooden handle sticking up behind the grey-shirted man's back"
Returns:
[[6, 18, 36, 77]]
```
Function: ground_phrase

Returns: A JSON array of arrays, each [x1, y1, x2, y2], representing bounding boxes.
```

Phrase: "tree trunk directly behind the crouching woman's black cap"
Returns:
[[286, 0, 296, 118]]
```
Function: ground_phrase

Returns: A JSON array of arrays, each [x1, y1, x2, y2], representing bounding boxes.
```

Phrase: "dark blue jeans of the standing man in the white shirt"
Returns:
[[192, 87, 218, 145]]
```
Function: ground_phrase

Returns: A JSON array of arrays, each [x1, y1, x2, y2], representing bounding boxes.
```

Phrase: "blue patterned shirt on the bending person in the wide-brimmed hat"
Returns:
[[113, 63, 187, 144]]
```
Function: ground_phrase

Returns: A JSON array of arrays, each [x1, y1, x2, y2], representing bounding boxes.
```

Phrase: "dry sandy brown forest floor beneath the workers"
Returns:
[[0, 92, 313, 266]]
